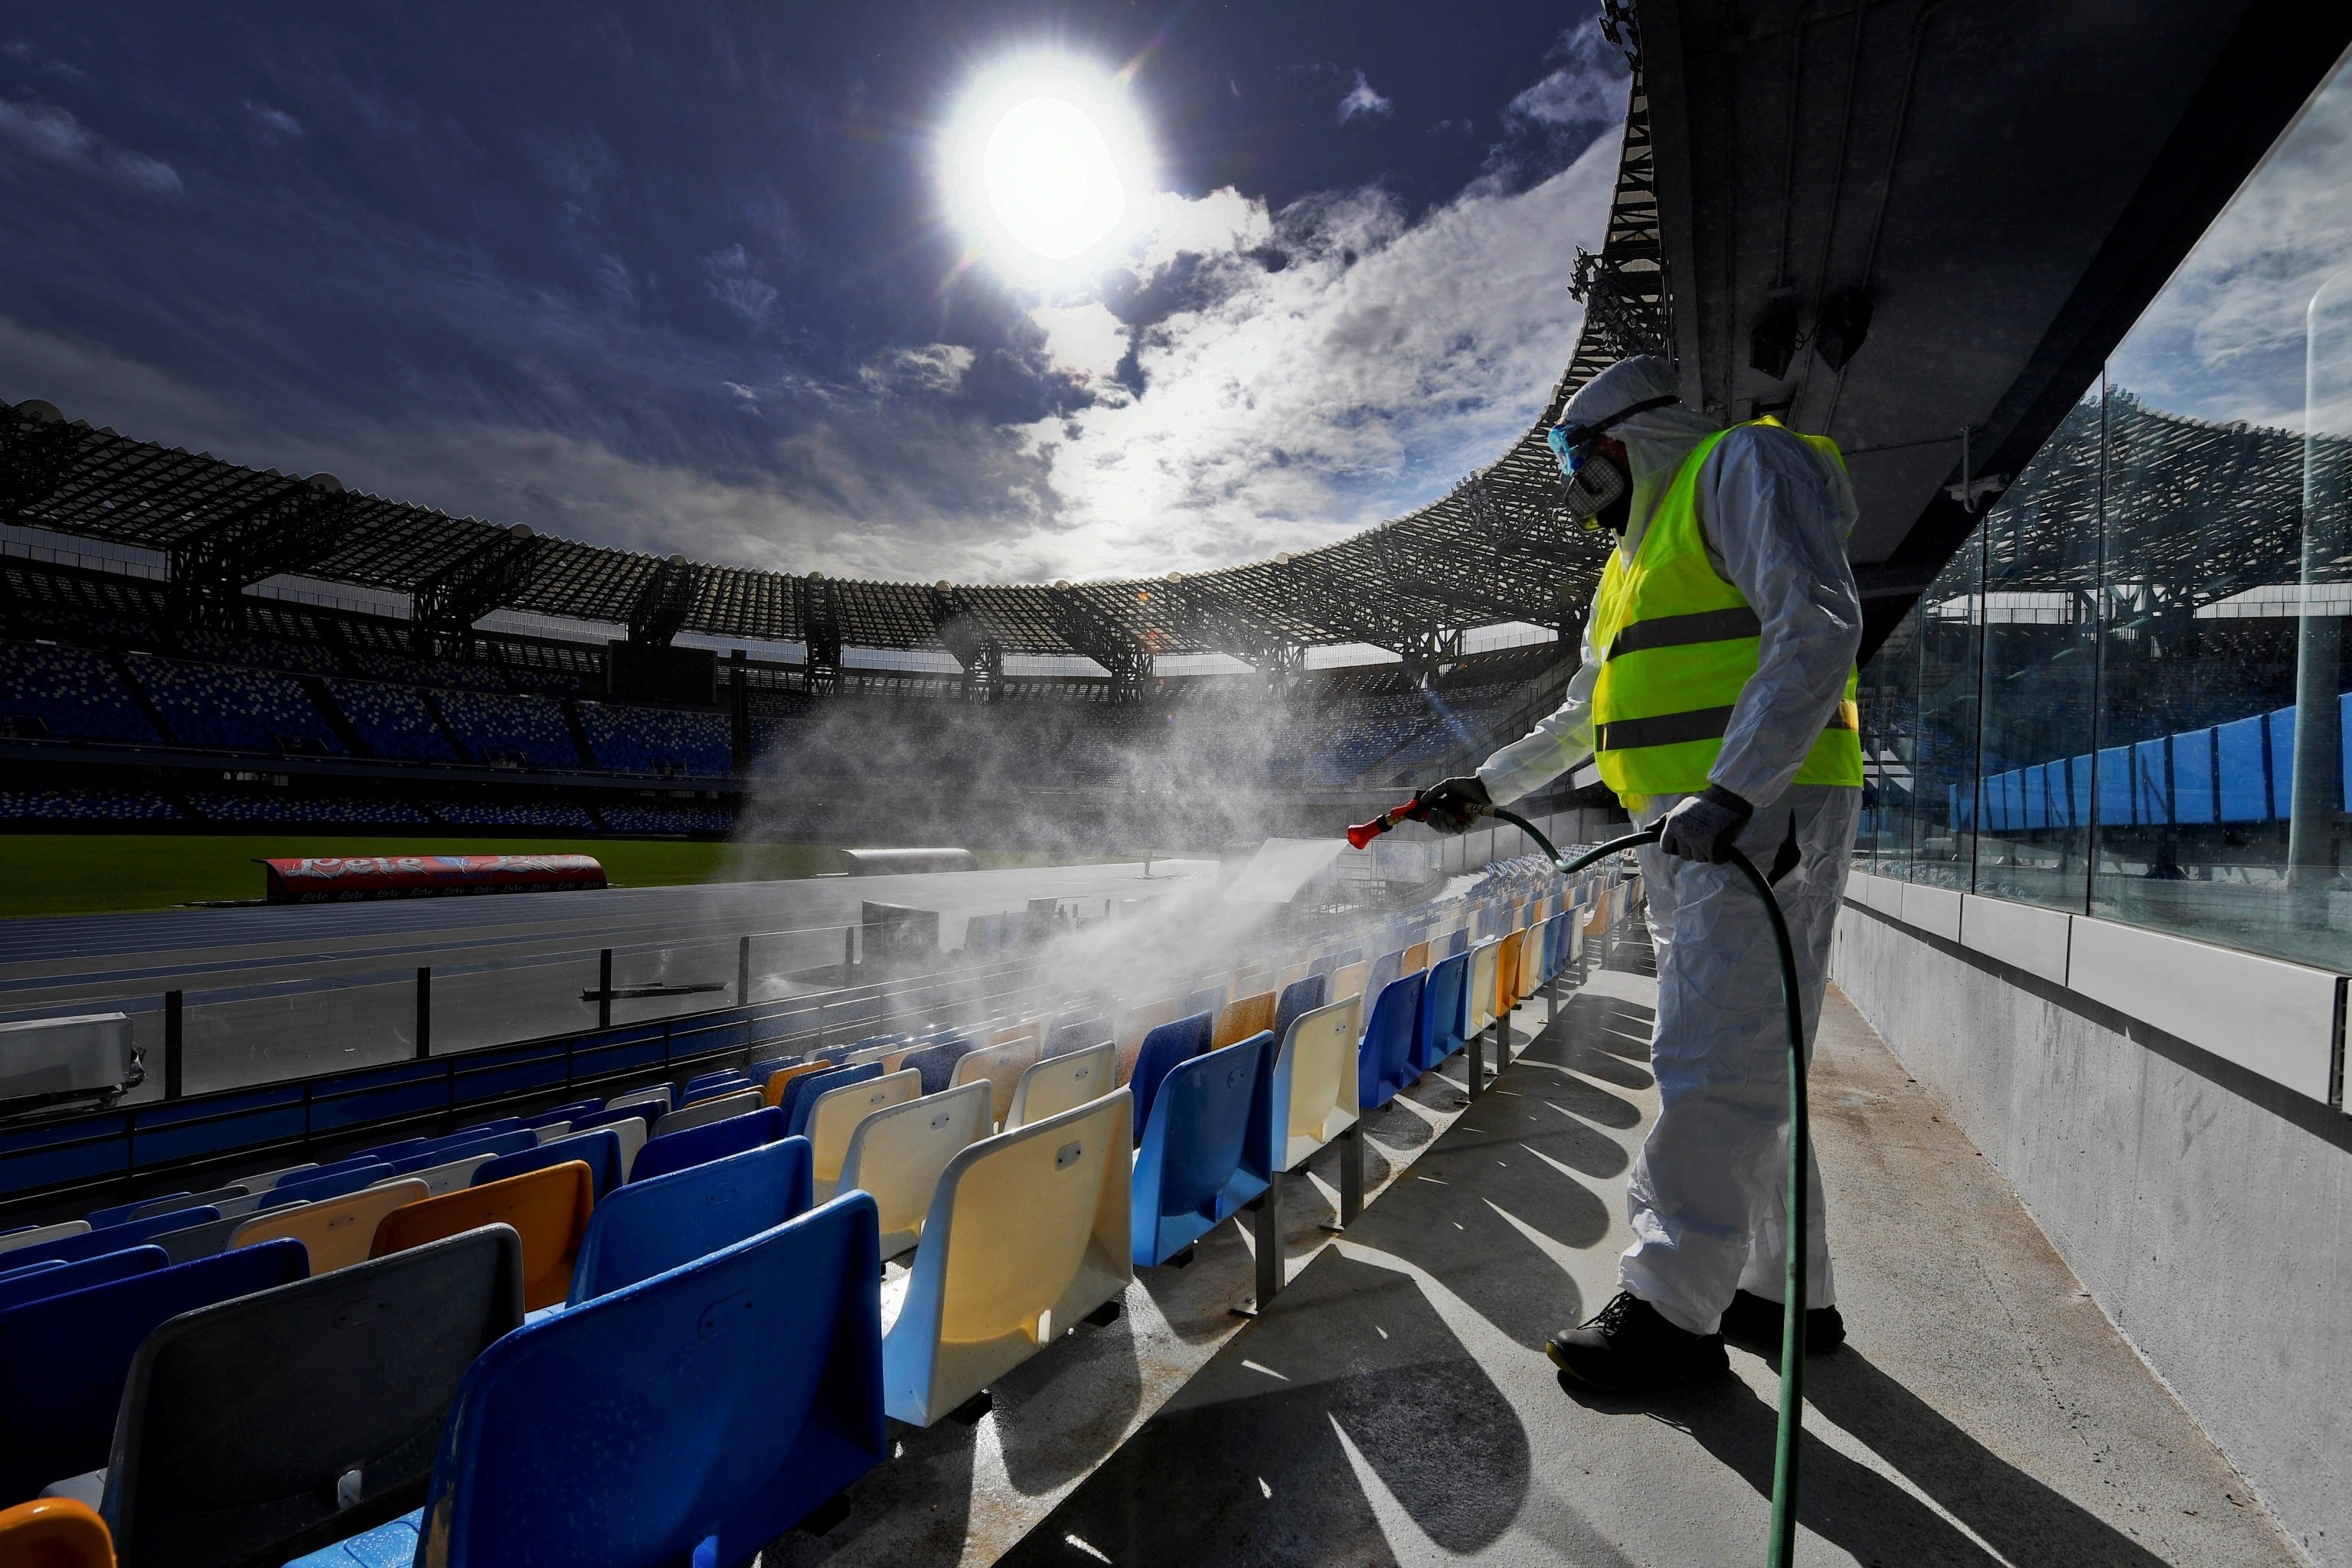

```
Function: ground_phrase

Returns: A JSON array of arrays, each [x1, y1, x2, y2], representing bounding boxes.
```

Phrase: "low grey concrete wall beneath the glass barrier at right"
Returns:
[[1830, 903, 2352, 1566]]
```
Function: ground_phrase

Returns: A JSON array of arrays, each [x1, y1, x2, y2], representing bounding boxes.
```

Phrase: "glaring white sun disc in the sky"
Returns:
[[939, 54, 1152, 285]]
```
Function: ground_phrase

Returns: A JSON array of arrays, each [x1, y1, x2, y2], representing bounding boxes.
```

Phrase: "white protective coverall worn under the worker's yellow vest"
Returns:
[[1479, 355, 1863, 1333]]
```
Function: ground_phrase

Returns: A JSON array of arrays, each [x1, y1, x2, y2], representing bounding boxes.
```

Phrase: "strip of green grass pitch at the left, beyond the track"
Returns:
[[0, 832, 1082, 920]]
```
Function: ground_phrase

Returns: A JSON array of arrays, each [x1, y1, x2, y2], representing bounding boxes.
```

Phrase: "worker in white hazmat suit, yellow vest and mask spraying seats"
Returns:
[[1418, 355, 1863, 1392]]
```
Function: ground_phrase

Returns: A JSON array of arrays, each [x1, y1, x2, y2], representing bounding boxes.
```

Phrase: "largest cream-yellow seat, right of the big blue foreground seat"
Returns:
[[884, 1099, 1133, 1427]]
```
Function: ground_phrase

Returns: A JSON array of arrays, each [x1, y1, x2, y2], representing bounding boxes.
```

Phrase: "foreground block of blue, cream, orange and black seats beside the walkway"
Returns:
[[0, 860, 1604, 1568]]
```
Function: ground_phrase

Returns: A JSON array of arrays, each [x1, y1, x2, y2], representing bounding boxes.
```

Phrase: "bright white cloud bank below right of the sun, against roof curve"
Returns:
[[998, 119, 1615, 576]]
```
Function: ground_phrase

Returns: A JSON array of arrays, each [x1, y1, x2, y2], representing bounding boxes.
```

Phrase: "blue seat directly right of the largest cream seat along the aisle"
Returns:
[[1129, 1030, 1275, 1269]]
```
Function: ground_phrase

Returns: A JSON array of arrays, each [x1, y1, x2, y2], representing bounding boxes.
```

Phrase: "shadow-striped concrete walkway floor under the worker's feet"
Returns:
[[766, 942, 2300, 1568]]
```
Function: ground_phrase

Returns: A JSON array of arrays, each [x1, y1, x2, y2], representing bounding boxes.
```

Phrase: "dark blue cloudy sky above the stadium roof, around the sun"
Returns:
[[0, 0, 1625, 580]]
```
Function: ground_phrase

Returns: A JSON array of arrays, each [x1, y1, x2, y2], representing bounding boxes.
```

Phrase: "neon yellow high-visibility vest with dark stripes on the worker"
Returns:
[[1592, 419, 1863, 811]]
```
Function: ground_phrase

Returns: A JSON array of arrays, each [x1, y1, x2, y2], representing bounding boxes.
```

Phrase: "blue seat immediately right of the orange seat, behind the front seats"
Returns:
[[569, 1138, 814, 1307]]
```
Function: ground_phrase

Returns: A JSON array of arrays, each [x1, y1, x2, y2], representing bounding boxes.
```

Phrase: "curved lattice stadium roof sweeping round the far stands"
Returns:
[[0, 12, 1670, 684]]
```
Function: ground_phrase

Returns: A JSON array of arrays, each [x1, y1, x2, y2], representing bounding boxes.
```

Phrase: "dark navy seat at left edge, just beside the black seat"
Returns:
[[0, 1241, 308, 1502]]
